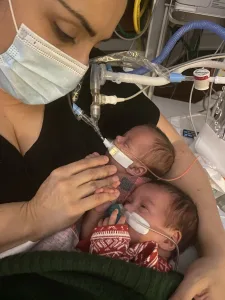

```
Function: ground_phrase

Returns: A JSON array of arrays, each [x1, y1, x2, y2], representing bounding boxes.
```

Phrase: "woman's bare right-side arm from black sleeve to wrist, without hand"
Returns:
[[158, 115, 225, 255]]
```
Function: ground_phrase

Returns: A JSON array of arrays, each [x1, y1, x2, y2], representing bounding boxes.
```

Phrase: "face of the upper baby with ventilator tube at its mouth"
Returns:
[[107, 126, 155, 173]]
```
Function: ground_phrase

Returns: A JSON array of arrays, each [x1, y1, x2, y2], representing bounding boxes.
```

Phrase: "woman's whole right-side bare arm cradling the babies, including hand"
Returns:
[[158, 115, 225, 300]]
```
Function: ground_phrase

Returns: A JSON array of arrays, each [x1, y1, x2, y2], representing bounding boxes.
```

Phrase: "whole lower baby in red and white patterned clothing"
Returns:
[[77, 181, 198, 272]]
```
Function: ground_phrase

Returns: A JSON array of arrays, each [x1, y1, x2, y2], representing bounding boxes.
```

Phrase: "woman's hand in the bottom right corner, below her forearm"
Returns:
[[170, 251, 225, 300]]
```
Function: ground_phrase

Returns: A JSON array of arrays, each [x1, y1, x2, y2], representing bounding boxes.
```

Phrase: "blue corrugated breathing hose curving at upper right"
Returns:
[[128, 21, 225, 75]]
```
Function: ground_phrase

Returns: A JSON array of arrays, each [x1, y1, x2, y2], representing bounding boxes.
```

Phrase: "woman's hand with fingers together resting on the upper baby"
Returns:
[[26, 156, 119, 240]]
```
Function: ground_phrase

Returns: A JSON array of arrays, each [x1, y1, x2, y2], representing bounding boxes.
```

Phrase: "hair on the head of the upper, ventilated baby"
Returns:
[[142, 124, 175, 178]]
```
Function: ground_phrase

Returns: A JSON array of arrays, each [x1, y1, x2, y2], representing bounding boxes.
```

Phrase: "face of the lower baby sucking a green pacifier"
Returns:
[[124, 183, 171, 243]]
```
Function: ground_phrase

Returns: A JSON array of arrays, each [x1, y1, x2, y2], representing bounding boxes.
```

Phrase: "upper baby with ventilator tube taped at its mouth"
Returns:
[[34, 125, 175, 250]]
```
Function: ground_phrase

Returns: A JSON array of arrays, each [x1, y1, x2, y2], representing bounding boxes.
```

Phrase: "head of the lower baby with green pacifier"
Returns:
[[124, 181, 198, 256]]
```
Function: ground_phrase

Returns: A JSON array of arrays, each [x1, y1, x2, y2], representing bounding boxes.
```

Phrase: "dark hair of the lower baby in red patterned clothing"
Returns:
[[151, 181, 199, 253]]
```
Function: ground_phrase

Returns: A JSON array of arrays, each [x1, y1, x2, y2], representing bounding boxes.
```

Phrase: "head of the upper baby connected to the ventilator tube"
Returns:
[[108, 125, 175, 177]]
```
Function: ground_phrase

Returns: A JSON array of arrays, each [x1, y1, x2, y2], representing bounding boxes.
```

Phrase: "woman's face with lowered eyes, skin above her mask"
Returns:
[[0, 0, 127, 64]]
